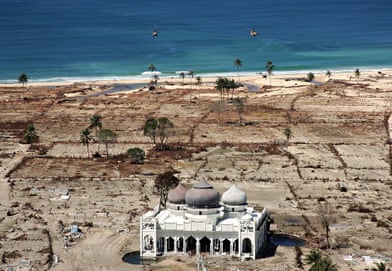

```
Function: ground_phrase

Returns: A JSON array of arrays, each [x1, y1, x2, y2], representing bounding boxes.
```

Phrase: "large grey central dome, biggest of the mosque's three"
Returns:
[[185, 180, 220, 208]]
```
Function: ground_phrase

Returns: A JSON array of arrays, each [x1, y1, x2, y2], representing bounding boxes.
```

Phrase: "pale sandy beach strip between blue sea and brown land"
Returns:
[[0, 68, 392, 88]]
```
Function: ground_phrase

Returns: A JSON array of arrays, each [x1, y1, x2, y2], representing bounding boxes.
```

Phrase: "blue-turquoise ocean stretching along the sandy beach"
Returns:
[[0, 0, 392, 83]]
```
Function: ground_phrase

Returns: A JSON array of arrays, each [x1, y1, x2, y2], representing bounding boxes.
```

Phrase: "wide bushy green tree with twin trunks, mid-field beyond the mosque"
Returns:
[[143, 117, 174, 150]]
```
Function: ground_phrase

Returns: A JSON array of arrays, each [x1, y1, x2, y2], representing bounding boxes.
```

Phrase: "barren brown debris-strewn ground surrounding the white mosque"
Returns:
[[0, 72, 392, 271]]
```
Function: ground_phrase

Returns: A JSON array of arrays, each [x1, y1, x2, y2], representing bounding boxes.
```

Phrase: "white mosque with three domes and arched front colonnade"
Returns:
[[140, 180, 269, 259]]
